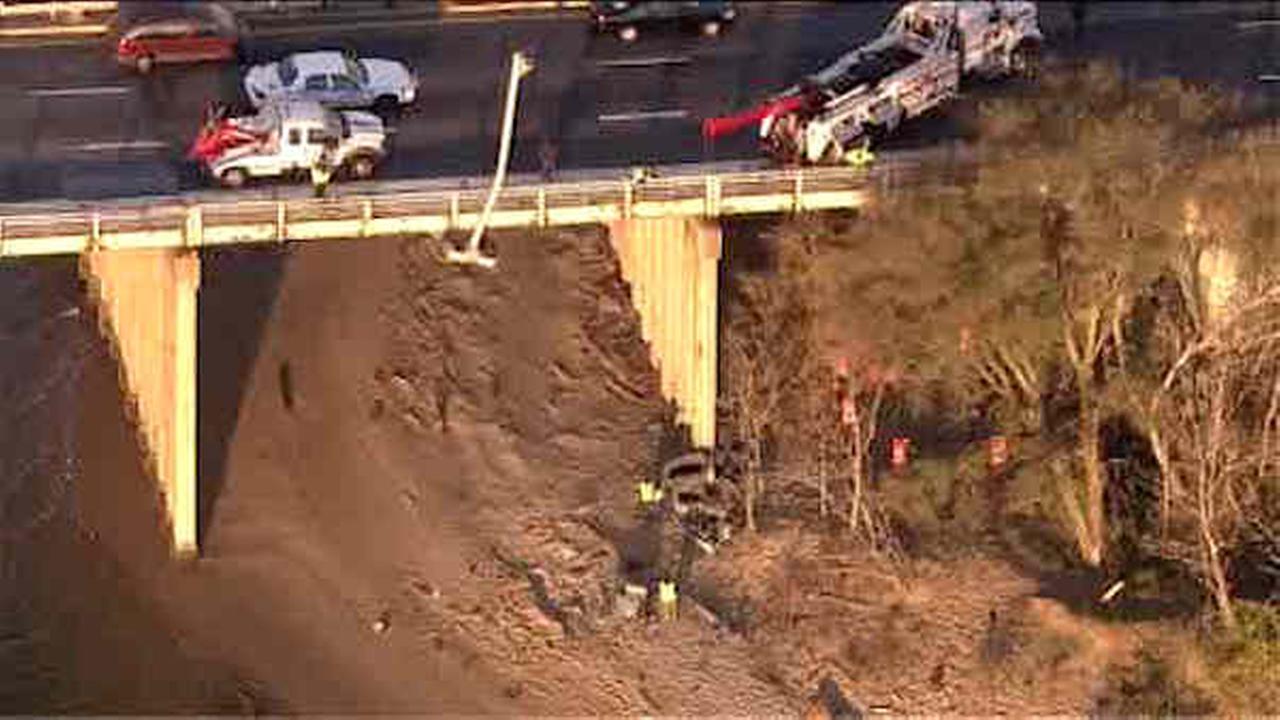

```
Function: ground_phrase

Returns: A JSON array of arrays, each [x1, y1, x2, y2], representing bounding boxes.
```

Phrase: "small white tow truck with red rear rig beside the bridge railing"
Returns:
[[202, 101, 387, 187]]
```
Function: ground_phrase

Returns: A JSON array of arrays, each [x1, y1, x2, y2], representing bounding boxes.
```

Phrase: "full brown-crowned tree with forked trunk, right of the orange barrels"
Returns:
[[974, 60, 1225, 566]]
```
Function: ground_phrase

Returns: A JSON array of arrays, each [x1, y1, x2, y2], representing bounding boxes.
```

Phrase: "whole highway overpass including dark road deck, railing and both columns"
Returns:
[[0, 3, 1280, 551]]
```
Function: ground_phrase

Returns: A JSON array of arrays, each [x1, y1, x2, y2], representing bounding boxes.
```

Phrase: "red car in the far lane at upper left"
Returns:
[[115, 5, 238, 73]]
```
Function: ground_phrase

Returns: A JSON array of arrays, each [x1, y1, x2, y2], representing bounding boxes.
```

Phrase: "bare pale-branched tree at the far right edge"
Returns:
[[1124, 175, 1280, 625]]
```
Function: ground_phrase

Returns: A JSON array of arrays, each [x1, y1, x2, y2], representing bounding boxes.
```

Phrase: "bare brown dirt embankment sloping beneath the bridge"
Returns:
[[0, 225, 1167, 715]]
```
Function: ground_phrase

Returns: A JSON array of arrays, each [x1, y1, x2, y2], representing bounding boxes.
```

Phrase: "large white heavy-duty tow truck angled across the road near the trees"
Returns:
[[755, 1, 1043, 164]]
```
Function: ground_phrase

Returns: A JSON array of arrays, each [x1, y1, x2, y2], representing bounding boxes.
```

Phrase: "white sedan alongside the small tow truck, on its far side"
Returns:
[[244, 50, 417, 110]]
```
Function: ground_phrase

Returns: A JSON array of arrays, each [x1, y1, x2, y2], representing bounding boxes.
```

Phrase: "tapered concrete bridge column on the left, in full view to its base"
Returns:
[[81, 250, 200, 555]]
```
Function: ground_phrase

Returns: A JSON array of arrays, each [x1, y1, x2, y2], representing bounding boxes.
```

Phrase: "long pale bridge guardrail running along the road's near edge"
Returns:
[[0, 167, 918, 256]]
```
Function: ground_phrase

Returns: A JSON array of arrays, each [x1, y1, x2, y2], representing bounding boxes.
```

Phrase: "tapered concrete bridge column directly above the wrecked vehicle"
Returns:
[[609, 218, 721, 450]]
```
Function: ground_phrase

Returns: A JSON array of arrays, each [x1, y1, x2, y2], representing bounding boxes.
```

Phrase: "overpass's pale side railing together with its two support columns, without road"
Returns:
[[0, 164, 896, 555]]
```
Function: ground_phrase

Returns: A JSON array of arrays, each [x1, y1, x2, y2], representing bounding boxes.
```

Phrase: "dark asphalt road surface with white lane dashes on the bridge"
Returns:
[[0, 1, 1280, 202]]
